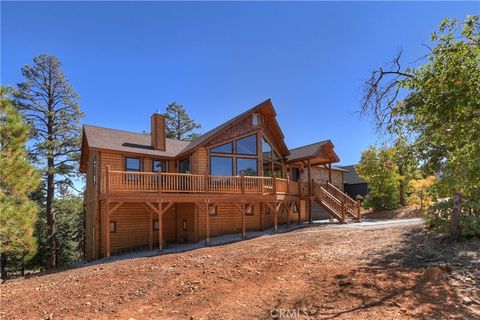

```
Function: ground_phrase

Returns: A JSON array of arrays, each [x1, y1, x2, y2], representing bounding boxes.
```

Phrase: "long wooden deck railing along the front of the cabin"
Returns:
[[100, 167, 300, 195]]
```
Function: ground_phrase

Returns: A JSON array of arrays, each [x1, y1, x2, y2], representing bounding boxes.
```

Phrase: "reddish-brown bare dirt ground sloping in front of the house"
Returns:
[[0, 224, 480, 319]]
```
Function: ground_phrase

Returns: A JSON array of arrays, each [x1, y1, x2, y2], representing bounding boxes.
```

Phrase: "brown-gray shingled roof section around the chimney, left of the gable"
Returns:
[[83, 125, 189, 157]]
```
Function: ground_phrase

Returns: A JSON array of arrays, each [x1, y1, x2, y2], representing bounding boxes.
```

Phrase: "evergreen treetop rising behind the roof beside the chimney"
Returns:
[[165, 102, 201, 140]]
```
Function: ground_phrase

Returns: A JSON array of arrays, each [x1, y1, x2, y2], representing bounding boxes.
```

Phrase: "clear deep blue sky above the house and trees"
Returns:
[[1, 1, 480, 164]]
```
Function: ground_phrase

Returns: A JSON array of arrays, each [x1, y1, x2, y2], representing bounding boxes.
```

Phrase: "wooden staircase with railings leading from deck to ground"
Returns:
[[312, 182, 361, 223]]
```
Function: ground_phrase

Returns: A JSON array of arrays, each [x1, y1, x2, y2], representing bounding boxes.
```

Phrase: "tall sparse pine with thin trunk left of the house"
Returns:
[[15, 54, 83, 269]]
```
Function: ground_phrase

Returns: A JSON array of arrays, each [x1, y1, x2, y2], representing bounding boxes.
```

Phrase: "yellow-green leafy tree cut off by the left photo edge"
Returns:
[[0, 87, 40, 279]]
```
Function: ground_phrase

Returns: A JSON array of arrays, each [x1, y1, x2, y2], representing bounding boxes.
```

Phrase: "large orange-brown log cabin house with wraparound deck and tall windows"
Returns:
[[80, 100, 360, 260]]
